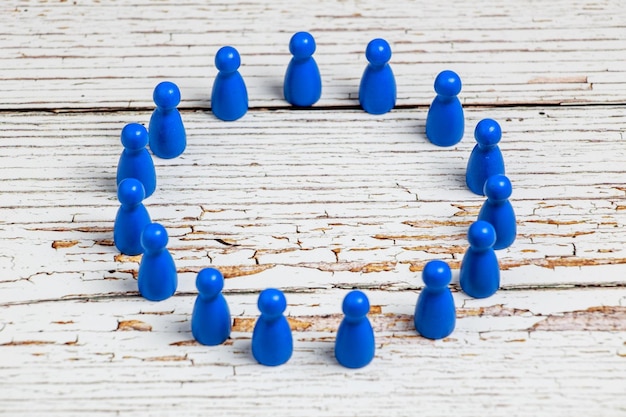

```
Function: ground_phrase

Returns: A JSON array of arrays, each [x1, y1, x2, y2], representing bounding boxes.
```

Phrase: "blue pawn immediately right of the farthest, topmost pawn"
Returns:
[[359, 39, 396, 114]]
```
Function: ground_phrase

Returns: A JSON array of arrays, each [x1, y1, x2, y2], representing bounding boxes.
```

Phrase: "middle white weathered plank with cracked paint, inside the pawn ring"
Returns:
[[0, 106, 626, 303]]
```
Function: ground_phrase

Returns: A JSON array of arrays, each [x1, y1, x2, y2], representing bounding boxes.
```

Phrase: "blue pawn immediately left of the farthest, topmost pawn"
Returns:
[[211, 46, 248, 121]]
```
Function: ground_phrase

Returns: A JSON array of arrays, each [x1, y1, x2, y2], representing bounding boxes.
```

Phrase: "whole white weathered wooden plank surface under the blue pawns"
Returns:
[[0, 0, 626, 417]]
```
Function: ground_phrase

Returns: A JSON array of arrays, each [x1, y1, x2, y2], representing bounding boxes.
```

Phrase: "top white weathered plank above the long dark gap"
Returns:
[[0, 0, 626, 109]]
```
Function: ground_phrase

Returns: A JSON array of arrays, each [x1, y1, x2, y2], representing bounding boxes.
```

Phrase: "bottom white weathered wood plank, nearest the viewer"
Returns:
[[0, 288, 626, 416]]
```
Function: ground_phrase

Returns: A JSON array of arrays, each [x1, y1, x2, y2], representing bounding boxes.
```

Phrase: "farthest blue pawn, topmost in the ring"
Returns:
[[283, 32, 322, 107]]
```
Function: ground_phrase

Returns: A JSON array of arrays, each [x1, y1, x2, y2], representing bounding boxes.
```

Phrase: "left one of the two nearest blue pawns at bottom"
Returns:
[[252, 288, 293, 366]]
